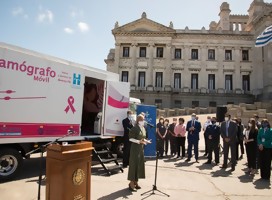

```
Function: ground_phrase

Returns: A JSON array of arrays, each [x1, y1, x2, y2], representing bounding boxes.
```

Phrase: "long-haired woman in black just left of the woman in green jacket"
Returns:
[[244, 118, 258, 175]]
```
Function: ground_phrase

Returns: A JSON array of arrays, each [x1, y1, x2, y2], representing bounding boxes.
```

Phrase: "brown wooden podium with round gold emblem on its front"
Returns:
[[46, 142, 93, 200]]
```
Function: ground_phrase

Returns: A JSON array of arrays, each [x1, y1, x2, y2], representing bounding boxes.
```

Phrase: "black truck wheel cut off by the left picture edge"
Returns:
[[0, 148, 23, 180]]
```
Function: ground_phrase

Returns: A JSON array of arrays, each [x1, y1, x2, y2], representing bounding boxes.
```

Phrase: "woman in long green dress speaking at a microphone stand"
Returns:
[[128, 114, 150, 192]]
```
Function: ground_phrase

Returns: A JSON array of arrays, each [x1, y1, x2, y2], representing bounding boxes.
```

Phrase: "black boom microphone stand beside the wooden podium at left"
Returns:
[[26, 130, 75, 200]]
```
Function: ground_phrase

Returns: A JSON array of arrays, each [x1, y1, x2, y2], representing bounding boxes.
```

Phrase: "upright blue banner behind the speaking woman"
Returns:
[[137, 105, 157, 157]]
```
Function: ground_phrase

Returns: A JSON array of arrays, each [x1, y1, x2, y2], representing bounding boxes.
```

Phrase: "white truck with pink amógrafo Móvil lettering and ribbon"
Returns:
[[0, 43, 130, 179]]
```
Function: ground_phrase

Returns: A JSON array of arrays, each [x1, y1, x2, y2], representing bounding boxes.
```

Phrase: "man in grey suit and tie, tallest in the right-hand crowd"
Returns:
[[221, 113, 238, 171]]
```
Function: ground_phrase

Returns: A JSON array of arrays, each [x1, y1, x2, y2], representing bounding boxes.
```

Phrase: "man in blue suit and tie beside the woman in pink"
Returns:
[[186, 113, 201, 163]]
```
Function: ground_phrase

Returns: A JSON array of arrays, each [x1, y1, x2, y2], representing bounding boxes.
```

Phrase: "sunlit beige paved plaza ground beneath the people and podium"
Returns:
[[0, 115, 272, 200]]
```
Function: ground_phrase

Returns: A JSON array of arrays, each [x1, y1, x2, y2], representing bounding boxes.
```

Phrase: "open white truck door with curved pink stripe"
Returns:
[[102, 81, 130, 136]]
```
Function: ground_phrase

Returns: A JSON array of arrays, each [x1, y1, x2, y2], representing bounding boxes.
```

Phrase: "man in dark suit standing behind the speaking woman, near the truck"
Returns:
[[122, 110, 133, 167]]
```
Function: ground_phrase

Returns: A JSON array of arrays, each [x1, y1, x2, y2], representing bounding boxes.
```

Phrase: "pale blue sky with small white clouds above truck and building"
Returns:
[[0, 0, 272, 69]]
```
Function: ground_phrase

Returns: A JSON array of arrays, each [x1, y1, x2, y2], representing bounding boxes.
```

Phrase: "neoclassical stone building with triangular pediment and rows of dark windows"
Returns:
[[105, 0, 272, 108]]
